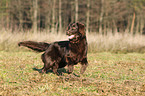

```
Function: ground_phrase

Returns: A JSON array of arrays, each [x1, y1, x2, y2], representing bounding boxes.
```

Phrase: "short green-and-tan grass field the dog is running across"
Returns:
[[0, 51, 145, 96]]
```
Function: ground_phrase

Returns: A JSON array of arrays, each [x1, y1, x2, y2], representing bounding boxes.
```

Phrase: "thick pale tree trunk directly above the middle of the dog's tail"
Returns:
[[33, 0, 38, 33]]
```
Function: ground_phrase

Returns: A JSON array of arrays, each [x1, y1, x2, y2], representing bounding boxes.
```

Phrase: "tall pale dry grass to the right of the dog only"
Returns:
[[88, 33, 145, 53]]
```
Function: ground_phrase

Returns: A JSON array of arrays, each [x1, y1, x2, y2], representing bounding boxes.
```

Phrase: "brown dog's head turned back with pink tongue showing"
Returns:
[[66, 22, 86, 43]]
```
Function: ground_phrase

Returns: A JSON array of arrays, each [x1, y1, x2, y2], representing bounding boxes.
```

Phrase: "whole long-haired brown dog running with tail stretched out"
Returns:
[[18, 23, 88, 75]]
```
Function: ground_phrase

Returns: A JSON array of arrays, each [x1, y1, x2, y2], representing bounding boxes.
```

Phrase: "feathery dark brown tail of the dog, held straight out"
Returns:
[[18, 41, 50, 52]]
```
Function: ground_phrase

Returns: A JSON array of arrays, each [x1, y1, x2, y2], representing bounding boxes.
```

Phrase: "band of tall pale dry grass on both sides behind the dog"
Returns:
[[0, 30, 145, 53]]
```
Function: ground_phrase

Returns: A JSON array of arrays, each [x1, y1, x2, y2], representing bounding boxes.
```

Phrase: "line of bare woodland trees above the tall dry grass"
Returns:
[[0, 0, 145, 35]]
